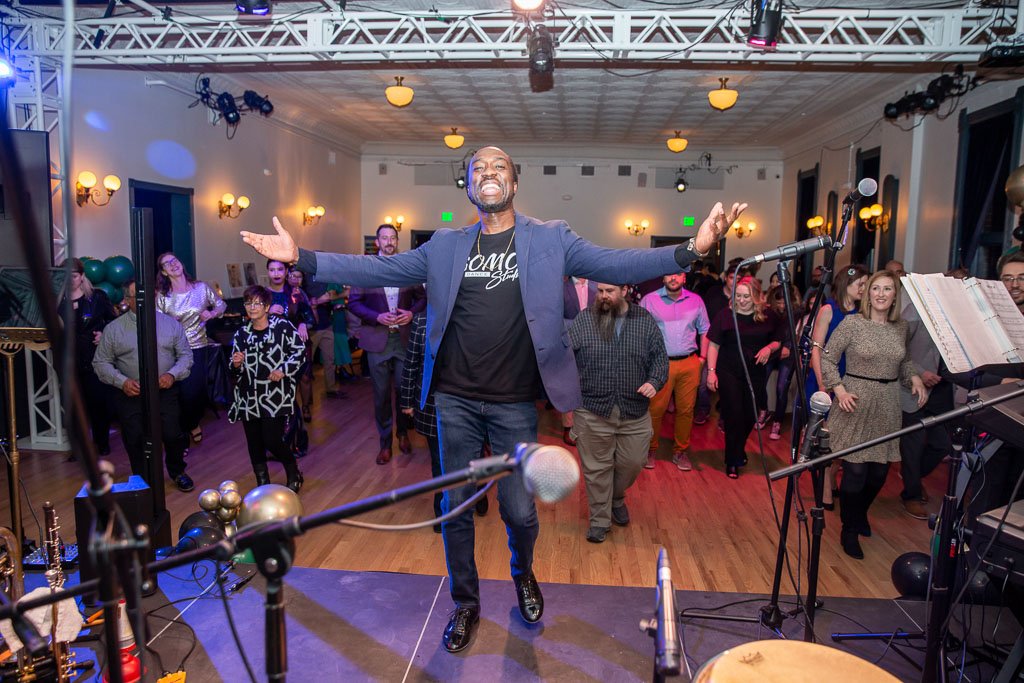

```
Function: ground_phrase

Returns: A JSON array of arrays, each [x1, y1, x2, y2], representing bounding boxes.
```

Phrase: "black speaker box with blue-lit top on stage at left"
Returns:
[[75, 475, 171, 605]]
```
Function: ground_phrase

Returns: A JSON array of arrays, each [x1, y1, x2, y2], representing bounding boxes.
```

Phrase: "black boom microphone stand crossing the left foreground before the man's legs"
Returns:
[[0, 450, 544, 681]]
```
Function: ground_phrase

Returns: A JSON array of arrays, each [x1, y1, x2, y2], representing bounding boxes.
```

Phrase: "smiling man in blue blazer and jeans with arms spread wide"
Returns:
[[242, 147, 746, 652]]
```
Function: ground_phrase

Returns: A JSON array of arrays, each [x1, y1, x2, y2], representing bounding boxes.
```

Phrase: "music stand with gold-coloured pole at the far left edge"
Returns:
[[0, 267, 67, 551]]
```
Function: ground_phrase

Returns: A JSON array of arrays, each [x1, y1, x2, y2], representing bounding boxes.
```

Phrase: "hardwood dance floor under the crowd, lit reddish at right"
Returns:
[[0, 370, 945, 598]]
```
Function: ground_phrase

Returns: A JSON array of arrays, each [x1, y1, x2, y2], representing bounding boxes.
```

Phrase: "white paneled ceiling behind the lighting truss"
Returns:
[[101, 0, 991, 148]]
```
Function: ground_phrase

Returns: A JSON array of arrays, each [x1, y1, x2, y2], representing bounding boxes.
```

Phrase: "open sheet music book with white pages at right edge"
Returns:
[[900, 272, 1024, 373]]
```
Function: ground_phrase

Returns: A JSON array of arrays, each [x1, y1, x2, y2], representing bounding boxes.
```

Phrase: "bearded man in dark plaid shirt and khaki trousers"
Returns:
[[569, 283, 669, 543]]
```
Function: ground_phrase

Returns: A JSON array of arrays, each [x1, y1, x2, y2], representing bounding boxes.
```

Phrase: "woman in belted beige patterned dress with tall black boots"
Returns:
[[821, 270, 928, 560]]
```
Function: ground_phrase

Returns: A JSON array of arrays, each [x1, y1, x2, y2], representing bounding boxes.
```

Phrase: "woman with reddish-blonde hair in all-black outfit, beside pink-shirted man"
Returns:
[[706, 275, 785, 479]]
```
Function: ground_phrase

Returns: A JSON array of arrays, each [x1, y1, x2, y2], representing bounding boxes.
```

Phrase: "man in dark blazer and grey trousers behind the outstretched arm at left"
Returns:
[[348, 223, 427, 465]]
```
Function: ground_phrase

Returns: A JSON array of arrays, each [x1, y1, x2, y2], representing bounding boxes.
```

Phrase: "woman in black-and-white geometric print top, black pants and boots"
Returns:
[[227, 285, 306, 493]]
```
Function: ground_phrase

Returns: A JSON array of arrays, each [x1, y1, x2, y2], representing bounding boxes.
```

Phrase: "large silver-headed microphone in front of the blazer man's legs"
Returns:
[[469, 442, 580, 503]]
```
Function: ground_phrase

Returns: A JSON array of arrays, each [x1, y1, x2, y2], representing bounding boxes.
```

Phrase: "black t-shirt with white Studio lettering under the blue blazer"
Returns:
[[434, 230, 541, 403]]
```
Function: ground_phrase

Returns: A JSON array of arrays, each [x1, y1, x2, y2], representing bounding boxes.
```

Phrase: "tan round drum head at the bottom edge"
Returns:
[[693, 640, 899, 683]]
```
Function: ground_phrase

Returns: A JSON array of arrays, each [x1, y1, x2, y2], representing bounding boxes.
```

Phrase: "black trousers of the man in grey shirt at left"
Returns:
[[114, 384, 185, 486]]
